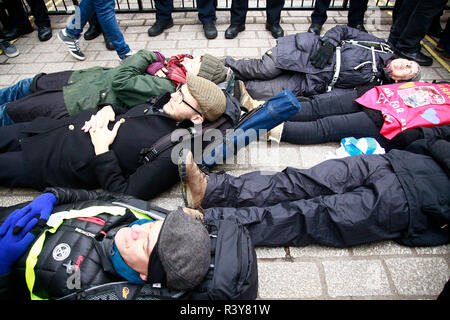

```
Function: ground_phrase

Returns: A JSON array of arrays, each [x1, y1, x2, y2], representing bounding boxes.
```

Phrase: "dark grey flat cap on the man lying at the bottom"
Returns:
[[158, 208, 211, 291]]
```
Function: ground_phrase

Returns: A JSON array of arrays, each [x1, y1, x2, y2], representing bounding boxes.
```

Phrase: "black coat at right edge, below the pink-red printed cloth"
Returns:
[[385, 125, 450, 246]]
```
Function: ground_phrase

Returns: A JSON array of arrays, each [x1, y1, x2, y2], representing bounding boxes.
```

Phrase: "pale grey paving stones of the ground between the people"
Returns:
[[0, 10, 450, 300]]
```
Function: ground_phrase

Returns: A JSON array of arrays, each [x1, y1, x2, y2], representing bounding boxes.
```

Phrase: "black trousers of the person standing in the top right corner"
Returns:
[[388, 0, 447, 53]]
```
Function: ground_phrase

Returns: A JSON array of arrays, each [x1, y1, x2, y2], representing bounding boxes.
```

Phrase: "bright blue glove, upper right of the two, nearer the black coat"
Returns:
[[13, 193, 56, 234]]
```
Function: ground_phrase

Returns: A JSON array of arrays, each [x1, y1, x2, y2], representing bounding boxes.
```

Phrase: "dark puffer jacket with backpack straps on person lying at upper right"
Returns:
[[275, 25, 393, 96]]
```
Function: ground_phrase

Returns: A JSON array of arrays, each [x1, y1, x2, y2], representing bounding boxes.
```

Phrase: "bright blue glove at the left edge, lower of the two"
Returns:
[[0, 209, 39, 276]]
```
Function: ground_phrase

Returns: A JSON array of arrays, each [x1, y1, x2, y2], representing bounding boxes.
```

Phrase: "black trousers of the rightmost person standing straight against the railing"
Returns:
[[311, 0, 369, 27]]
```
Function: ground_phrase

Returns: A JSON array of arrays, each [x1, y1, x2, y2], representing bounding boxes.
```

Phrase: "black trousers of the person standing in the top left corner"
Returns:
[[3, 0, 50, 28]]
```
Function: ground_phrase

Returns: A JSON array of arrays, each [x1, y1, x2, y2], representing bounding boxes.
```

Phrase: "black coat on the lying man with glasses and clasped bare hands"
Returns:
[[22, 96, 178, 199]]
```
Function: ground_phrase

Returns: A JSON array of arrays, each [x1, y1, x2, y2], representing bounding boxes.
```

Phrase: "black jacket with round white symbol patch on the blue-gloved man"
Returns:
[[0, 188, 164, 300]]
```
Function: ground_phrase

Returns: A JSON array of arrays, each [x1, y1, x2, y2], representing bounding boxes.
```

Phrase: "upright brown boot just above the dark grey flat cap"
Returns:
[[178, 149, 208, 209]]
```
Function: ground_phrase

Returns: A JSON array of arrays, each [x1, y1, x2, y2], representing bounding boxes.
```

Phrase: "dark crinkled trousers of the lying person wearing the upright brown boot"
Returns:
[[202, 155, 409, 247]]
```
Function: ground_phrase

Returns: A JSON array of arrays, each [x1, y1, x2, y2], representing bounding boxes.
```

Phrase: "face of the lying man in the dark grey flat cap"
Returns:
[[114, 220, 163, 280]]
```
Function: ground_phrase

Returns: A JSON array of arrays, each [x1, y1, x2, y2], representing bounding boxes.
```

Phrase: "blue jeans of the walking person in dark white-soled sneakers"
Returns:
[[66, 0, 131, 56]]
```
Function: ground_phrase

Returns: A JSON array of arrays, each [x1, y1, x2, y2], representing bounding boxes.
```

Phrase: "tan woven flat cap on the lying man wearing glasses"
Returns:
[[186, 73, 227, 121]]
